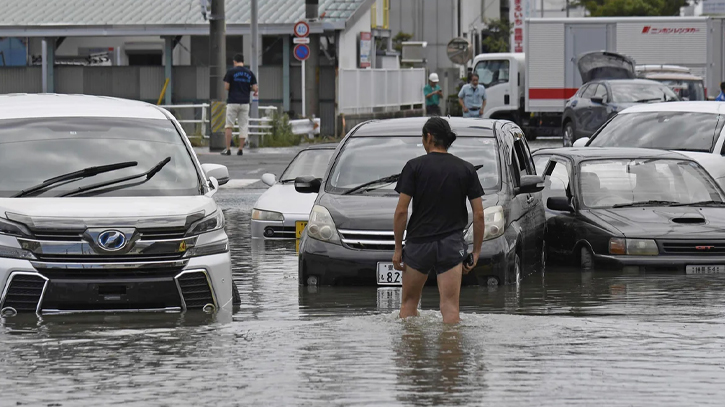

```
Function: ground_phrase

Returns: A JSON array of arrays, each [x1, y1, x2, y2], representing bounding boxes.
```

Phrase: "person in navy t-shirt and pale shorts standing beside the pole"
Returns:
[[222, 54, 258, 155]]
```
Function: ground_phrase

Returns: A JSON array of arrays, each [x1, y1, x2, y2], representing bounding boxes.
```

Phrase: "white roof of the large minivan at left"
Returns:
[[0, 93, 168, 120]]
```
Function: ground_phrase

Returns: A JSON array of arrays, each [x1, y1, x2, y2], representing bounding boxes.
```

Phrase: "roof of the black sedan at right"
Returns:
[[532, 147, 692, 162]]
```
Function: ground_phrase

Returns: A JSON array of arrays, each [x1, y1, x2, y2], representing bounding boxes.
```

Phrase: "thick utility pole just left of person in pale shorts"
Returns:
[[209, 0, 227, 150]]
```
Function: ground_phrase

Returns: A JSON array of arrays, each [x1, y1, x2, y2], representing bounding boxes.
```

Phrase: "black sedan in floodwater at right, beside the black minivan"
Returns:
[[534, 148, 725, 274]]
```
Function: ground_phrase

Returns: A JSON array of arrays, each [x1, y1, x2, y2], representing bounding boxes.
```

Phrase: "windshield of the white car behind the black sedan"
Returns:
[[589, 112, 723, 152]]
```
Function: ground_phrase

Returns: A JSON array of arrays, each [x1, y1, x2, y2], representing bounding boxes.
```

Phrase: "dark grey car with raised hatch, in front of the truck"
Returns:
[[561, 51, 679, 146]]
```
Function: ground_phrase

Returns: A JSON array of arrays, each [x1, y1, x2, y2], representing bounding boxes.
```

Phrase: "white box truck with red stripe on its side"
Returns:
[[473, 17, 725, 139]]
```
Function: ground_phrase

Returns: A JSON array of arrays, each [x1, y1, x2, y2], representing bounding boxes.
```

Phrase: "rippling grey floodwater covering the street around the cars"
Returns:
[[0, 191, 725, 406]]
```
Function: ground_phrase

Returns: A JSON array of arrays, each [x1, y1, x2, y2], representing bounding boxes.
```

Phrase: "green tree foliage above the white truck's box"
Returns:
[[577, 0, 689, 17]]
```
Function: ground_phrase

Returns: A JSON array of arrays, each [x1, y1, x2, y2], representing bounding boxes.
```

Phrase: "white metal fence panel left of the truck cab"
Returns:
[[338, 68, 426, 114]]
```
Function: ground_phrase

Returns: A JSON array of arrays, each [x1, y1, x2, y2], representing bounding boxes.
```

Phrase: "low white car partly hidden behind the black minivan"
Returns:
[[252, 144, 337, 239]]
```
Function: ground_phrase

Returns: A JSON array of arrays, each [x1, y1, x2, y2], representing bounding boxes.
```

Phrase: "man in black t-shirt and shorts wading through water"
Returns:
[[393, 117, 484, 323]]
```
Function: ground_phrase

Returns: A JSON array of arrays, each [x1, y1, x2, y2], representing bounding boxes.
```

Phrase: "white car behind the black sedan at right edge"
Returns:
[[574, 102, 725, 188]]
